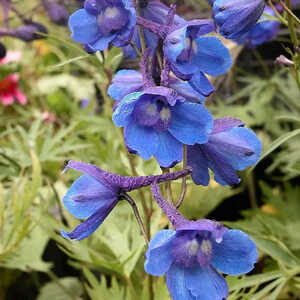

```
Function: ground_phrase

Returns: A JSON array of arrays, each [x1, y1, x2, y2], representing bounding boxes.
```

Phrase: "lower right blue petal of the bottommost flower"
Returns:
[[185, 266, 228, 300]]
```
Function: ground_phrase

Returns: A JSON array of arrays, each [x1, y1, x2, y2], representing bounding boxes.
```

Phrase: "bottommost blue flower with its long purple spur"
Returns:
[[145, 184, 258, 300]]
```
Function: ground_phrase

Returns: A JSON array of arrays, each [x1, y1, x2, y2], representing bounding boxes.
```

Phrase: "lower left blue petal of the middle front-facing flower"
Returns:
[[124, 119, 158, 160]]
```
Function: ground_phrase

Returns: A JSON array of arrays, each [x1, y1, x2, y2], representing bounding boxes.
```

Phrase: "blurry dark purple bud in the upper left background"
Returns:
[[12, 22, 48, 42]]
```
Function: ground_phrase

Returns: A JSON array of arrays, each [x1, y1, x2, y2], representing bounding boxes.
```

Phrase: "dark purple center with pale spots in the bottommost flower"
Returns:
[[172, 230, 213, 268]]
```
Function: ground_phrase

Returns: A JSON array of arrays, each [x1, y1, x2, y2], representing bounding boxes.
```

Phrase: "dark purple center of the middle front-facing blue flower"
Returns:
[[133, 94, 171, 131]]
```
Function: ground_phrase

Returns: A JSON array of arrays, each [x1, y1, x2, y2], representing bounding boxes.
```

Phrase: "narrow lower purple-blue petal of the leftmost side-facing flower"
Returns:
[[61, 201, 117, 241]]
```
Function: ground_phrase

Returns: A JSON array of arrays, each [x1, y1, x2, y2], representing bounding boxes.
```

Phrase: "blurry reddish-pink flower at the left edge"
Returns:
[[0, 73, 27, 106]]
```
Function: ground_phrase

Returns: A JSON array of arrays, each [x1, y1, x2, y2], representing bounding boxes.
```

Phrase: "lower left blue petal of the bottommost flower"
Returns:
[[166, 264, 196, 300]]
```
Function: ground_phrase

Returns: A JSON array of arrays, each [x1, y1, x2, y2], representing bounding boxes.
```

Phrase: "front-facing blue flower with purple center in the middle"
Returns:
[[113, 86, 213, 167]]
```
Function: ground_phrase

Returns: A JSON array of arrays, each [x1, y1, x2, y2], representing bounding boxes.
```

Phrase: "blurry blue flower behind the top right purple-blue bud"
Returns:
[[237, 6, 280, 48]]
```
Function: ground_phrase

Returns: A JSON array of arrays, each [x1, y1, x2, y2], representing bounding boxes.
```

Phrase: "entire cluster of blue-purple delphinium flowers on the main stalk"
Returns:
[[61, 0, 265, 300]]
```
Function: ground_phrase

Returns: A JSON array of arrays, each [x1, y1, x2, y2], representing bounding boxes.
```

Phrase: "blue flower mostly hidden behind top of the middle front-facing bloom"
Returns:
[[107, 70, 205, 104]]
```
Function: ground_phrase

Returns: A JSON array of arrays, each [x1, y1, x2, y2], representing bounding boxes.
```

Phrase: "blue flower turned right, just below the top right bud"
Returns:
[[163, 20, 232, 96]]
